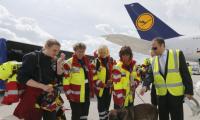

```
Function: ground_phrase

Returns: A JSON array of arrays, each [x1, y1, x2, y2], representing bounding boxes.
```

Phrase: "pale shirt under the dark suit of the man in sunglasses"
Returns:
[[158, 50, 167, 74]]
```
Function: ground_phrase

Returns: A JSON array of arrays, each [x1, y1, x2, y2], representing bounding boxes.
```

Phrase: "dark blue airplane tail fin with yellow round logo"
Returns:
[[125, 3, 181, 41]]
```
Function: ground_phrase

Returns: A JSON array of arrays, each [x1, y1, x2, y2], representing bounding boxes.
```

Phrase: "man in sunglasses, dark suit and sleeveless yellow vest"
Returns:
[[141, 38, 193, 120]]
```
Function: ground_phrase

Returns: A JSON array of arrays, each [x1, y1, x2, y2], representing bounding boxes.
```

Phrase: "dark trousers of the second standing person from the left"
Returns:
[[70, 101, 90, 120]]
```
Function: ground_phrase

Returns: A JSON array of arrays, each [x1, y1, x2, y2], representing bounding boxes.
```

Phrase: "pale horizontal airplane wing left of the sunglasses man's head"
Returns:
[[103, 34, 151, 55]]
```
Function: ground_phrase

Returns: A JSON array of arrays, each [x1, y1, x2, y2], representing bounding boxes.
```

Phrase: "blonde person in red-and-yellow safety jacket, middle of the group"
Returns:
[[93, 45, 113, 120]]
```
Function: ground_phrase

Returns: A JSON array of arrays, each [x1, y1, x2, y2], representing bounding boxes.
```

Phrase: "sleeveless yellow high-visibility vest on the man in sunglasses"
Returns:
[[152, 50, 184, 96]]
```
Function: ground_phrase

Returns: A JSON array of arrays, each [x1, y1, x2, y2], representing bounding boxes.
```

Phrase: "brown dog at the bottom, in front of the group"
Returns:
[[109, 104, 158, 120]]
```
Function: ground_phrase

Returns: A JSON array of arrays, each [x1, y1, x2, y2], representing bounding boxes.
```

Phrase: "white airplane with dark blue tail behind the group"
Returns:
[[103, 3, 200, 65]]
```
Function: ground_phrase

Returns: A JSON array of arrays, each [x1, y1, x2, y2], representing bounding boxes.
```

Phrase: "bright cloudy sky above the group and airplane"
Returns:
[[0, 0, 200, 59]]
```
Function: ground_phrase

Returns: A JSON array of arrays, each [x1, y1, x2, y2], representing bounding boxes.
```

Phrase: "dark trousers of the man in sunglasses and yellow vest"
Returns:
[[158, 93, 184, 120]]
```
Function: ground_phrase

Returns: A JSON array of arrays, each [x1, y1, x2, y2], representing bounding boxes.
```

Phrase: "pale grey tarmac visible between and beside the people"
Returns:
[[0, 75, 200, 120]]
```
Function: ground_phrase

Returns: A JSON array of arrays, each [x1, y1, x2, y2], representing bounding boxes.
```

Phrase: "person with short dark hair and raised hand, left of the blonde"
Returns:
[[63, 43, 94, 120]]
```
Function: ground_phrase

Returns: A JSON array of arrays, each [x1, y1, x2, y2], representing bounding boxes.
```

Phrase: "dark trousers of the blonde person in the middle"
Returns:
[[97, 88, 111, 120]]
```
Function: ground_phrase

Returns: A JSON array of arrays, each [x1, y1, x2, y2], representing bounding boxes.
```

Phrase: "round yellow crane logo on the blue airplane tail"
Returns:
[[136, 13, 154, 31]]
